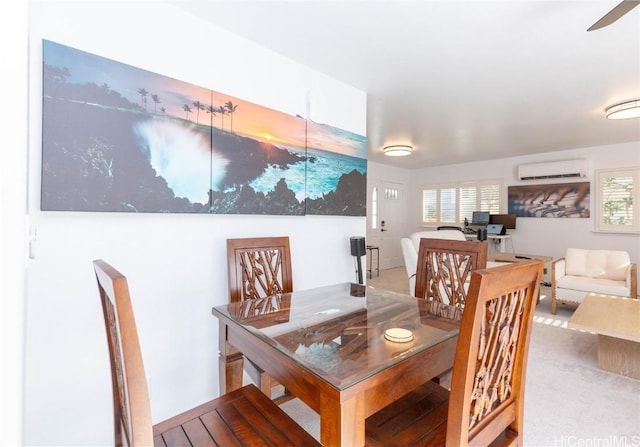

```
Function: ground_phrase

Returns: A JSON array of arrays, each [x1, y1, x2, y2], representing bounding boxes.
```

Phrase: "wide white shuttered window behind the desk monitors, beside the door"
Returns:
[[422, 179, 503, 226]]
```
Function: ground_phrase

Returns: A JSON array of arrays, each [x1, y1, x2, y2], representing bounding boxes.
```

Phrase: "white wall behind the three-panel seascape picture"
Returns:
[[24, 1, 366, 446]]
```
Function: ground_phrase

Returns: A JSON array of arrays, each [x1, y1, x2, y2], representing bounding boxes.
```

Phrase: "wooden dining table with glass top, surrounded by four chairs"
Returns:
[[212, 283, 462, 447]]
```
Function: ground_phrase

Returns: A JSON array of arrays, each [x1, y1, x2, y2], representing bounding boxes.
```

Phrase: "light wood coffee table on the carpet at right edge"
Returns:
[[568, 293, 640, 379]]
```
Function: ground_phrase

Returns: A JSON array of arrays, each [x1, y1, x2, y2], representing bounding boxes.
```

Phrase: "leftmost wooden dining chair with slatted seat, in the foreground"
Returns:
[[93, 260, 320, 447]]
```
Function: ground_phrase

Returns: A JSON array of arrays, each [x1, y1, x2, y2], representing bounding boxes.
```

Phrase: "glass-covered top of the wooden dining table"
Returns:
[[213, 283, 462, 390]]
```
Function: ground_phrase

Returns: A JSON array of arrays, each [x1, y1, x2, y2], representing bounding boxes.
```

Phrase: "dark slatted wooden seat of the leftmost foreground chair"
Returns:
[[153, 385, 321, 447]]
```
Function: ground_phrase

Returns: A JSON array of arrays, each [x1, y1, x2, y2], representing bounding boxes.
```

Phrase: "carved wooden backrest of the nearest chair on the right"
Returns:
[[447, 261, 544, 446]]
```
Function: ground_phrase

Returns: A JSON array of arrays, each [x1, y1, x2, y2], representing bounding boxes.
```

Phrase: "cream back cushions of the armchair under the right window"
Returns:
[[565, 248, 631, 281]]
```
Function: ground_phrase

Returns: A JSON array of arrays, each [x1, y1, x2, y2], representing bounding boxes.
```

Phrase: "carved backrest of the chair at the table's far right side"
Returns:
[[415, 238, 487, 307]]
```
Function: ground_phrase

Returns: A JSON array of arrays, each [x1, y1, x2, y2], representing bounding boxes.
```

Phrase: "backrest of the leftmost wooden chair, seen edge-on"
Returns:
[[93, 260, 153, 446]]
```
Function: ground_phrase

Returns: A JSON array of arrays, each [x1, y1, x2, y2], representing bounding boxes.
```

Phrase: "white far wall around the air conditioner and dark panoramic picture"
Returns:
[[407, 142, 640, 263]]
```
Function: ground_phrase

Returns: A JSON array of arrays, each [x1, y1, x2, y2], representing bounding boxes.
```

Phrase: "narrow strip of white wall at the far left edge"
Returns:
[[0, 2, 28, 446]]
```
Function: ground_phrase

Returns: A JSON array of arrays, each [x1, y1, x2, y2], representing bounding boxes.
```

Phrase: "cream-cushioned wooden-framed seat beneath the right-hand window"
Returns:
[[551, 248, 638, 315]]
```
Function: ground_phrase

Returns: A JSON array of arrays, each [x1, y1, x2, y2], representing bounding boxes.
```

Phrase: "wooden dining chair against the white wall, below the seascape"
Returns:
[[227, 236, 293, 403]]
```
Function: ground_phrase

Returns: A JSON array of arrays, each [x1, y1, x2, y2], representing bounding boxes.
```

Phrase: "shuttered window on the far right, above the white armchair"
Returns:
[[596, 168, 640, 233]]
